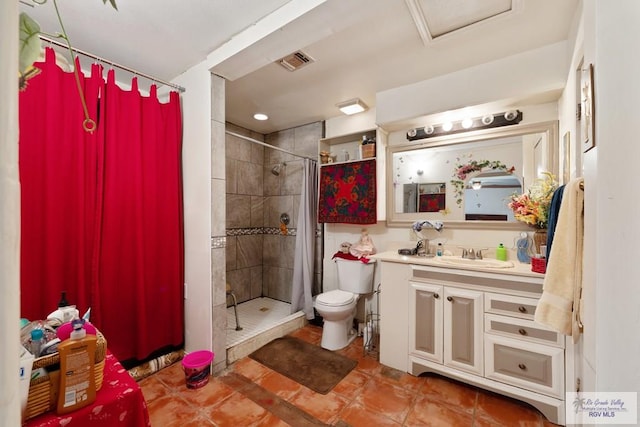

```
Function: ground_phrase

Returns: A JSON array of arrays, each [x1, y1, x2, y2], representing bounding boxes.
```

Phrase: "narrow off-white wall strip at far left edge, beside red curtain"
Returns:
[[0, 0, 20, 426]]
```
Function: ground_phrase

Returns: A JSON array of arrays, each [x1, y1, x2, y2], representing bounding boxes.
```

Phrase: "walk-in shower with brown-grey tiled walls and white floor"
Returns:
[[226, 128, 323, 363]]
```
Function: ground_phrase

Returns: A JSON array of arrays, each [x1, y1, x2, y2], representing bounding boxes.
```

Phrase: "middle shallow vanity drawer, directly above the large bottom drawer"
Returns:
[[484, 314, 564, 348]]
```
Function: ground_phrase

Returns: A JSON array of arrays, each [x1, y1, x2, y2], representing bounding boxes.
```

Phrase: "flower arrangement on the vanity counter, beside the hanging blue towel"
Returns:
[[508, 172, 558, 228]]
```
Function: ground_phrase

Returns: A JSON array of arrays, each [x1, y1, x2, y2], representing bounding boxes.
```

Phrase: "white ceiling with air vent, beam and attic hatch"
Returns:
[[20, 0, 580, 133]]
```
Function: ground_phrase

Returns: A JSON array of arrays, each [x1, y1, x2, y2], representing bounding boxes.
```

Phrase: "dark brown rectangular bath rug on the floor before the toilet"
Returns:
[[249, 336, 358, 394]]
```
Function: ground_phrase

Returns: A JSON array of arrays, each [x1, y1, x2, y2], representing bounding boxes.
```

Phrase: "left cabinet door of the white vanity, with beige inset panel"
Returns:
[[409, 282, 443, 363]]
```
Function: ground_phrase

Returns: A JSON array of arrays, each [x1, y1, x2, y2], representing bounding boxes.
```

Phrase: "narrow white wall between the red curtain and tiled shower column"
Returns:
[[173, 63, 213, 352]]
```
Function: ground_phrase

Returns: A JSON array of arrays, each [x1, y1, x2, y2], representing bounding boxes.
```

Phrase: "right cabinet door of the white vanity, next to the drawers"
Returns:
[[444, 288, 484, 375]]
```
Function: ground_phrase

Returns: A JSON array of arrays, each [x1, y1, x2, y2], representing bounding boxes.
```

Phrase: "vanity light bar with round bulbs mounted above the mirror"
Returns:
[[407, 110, 522, 141]]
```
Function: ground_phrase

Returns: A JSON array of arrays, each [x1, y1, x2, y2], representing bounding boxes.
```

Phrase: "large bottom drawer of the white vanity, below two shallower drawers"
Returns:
[[485, 334, 564, 398]]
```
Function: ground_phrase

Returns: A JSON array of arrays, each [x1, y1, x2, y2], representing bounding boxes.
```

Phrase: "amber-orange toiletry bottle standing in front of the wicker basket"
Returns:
[[56, 319, 97, 414]]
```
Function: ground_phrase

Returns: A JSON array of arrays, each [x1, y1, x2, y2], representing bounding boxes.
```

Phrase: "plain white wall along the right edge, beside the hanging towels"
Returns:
[[584, 0, 640, 391]]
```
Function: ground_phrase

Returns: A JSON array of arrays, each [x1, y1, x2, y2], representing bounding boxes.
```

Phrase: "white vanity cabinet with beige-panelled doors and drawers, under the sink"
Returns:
[[374, 252, 572, 424]]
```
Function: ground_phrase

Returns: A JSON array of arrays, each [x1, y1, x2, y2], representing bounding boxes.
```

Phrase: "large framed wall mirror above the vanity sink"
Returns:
[[387, 121, 558, 229]]
